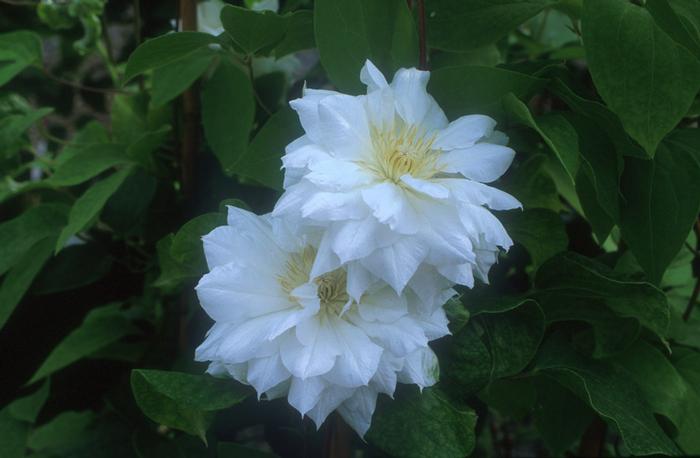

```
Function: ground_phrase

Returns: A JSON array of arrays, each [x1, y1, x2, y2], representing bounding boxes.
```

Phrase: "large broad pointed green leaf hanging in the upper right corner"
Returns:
[[582, 0, 700, 157]]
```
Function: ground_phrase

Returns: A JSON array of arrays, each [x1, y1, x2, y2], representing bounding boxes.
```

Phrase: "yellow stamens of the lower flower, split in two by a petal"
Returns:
[[277, 246, 350, 315]]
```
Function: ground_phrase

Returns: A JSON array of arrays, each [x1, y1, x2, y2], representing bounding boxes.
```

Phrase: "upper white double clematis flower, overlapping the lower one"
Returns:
[[273, 61, 521, 302]]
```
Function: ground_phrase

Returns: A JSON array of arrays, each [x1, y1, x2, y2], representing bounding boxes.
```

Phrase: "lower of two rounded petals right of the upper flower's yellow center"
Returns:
[[438, 143, 515, 183]]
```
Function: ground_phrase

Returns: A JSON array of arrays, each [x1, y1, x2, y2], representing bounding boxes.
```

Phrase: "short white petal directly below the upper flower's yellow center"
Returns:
[[362, 183, 422, 234]]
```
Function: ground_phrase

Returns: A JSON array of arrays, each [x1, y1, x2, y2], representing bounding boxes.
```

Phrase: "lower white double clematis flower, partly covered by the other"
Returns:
[[195, 207, 454, 435]]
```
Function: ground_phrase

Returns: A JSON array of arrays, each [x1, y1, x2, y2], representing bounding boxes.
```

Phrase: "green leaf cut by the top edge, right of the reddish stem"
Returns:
[[425, 0, 557, 51]]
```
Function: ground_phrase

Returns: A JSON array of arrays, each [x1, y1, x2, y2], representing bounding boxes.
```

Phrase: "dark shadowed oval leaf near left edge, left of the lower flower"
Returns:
[[32, 243, 114, 294]]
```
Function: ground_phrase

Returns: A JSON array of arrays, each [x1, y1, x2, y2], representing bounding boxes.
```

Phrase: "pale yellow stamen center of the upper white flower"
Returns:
[[365, 124, 439, 184]]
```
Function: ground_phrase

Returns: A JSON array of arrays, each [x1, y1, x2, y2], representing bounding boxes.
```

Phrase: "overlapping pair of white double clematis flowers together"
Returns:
[[196, 61, 520, 435]]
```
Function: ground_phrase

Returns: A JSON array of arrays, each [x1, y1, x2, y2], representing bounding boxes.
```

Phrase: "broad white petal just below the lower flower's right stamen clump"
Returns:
[[325, 314, 382, 387]]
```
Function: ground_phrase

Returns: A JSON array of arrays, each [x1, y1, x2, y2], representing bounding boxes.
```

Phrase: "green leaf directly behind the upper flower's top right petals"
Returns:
[[428, 65, 545, 119]]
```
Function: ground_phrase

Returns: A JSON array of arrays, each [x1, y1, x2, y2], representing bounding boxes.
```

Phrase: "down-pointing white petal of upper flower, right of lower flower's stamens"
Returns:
[[362, 238, 428, 294]]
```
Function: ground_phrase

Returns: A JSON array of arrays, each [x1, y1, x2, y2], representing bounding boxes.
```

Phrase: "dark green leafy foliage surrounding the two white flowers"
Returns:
[[0, 0, 700, 458]]
